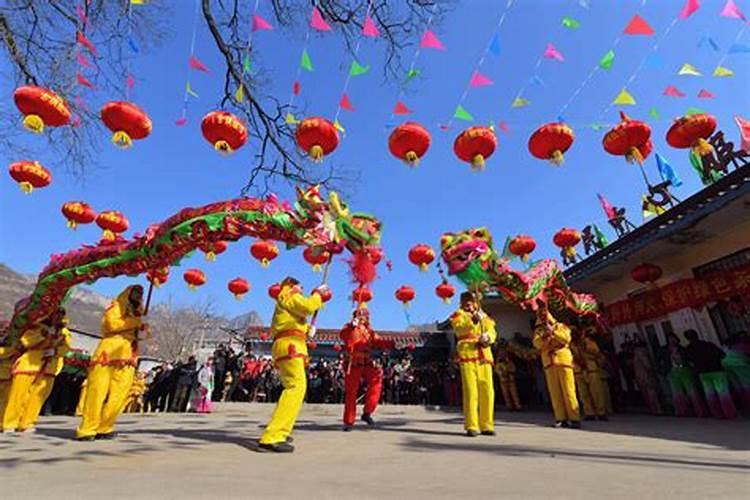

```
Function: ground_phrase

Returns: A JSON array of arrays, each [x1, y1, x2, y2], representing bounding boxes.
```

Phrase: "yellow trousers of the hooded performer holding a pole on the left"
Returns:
[[76, 365, 135, 437]]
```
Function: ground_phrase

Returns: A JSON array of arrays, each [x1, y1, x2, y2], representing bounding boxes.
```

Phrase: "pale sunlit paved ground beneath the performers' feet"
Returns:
[[0, 404, 750, 500]]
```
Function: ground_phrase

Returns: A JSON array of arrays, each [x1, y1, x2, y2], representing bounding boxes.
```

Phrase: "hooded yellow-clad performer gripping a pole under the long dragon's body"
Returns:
[[76, 285, 146, 441]]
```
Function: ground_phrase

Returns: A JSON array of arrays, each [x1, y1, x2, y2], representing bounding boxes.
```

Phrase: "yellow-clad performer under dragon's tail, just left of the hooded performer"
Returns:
[[3, 309, 71, 432]]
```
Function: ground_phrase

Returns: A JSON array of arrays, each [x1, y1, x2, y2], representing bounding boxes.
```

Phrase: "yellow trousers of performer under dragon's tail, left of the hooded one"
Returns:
[[3, 373, 55, 431]]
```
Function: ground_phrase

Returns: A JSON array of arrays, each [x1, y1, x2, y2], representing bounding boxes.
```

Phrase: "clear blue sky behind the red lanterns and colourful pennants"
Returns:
[[0, 0, 750, 329]]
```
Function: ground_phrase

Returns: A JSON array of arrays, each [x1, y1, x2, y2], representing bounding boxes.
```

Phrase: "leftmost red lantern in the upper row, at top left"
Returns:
[[13, 85, 70, 134]]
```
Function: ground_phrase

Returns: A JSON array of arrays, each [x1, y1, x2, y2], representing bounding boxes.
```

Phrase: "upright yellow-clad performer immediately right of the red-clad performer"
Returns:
[[451, 292, 497, 437]]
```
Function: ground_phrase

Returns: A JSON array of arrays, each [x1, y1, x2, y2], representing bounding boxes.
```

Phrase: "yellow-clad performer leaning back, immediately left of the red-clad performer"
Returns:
[[259, 277, 327, 453]]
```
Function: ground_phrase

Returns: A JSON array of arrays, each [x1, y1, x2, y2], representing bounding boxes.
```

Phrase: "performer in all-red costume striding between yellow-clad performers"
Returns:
[[339, 304, 394, 432]]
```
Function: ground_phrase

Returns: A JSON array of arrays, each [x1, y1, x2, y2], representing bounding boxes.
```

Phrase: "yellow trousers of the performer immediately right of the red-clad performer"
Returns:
[[460, 361, 495, 431]]
